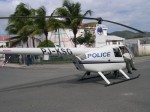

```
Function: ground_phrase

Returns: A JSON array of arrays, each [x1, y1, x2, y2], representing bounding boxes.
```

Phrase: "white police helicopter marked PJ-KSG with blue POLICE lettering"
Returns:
[[0, 16, 144, 85]]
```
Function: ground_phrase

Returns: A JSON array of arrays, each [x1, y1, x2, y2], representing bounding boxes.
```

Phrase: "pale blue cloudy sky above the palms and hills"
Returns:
[[0, 0, 150, 35]]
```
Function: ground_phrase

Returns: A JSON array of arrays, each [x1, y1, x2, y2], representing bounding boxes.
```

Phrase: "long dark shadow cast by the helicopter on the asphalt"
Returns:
[[0, 73, 136, 92]]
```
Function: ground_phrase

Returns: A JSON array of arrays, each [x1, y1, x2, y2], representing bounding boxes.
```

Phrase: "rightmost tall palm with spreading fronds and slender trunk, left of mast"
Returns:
[[55, 0, 92, 47]]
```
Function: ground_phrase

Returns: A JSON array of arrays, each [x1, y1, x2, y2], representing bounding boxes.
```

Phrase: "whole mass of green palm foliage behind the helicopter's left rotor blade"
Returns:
[[6, 0, 92, 47]]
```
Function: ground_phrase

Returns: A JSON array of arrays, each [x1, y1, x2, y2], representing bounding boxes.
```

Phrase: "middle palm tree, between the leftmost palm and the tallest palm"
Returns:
[[28, 6, 65, 47]]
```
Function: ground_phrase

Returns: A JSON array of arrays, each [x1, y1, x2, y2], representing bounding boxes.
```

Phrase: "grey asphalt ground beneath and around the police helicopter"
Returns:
[[0, 57, 150, 112]]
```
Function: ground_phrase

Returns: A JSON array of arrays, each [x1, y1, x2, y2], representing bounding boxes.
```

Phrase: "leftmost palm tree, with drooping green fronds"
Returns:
[[6, 3, 31, 47]]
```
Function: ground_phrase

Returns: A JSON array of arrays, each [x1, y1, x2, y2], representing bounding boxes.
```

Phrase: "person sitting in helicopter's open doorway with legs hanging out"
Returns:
[[120, 47, 137, 74]]
